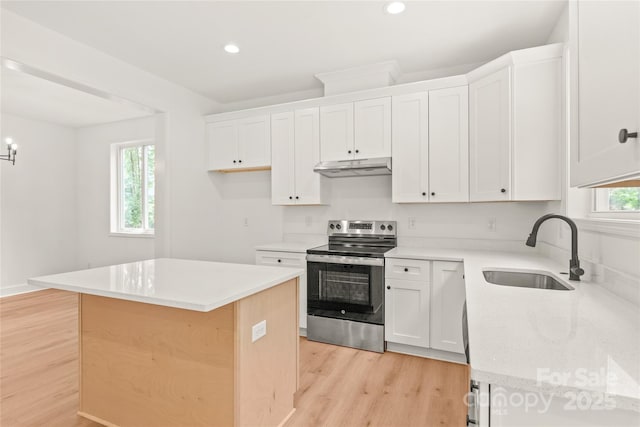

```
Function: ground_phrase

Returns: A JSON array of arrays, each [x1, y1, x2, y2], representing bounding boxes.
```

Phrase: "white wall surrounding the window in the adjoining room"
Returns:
[[75, 117, 155, 268]]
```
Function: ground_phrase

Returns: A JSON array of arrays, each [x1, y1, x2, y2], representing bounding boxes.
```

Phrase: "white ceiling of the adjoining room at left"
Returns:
[[0, 68, 149, 128]]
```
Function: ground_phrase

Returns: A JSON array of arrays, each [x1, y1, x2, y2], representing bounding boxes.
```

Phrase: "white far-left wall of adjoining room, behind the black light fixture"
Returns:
[[0, 114, 76, 294]]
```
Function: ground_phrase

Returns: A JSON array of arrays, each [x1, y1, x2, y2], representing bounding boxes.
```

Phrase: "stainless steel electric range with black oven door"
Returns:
[[307, 220, 397, 352]]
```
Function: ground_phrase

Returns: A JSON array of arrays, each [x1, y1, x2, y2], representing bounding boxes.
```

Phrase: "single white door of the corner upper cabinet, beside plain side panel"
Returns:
[[469, 67, 511, 202]]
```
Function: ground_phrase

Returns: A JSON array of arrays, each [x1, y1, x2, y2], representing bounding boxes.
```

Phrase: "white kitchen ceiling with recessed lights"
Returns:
[[2, 0, 565, 103]]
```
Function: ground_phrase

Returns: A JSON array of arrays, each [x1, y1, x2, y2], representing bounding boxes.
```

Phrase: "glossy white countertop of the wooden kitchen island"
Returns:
[[28, 258, 303, 311]]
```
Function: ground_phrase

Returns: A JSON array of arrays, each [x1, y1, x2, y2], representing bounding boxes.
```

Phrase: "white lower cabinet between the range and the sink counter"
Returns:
[[385, 258, 465, 354]]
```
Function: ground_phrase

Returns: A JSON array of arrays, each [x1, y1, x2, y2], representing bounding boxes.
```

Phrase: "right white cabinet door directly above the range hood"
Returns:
[[353, 96, 391, 159]]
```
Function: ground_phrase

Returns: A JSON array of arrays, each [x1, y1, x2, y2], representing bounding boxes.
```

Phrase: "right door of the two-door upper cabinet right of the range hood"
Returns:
[[429, 86, 469, 202]]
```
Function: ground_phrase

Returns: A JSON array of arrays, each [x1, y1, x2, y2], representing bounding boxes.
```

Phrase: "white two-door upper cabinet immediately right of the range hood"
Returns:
[[392, 86, 469, 203]]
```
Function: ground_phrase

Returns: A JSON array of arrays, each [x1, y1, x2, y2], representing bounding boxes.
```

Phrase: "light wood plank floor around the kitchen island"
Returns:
[[0, 290, 468, 427]]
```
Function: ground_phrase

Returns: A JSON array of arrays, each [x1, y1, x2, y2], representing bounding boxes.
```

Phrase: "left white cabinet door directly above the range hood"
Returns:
[[320, 102, 353, 162]]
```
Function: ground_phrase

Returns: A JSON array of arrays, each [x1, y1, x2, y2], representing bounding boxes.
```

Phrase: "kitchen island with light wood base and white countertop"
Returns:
[[29, 259, 302, 427]]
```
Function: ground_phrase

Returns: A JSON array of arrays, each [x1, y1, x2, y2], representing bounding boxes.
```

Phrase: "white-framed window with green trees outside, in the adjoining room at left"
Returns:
[[111, 141, 155, 235]]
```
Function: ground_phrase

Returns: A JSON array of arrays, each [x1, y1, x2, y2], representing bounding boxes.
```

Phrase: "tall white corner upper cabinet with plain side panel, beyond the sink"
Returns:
[[467, 44, 564, 202]]
